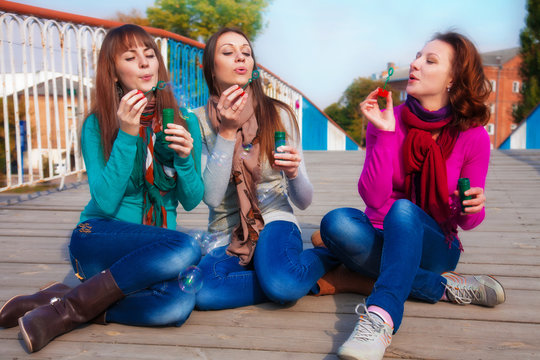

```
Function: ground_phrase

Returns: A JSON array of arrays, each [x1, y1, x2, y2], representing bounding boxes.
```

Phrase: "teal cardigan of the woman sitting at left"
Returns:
[[80, 114, 204, 229]]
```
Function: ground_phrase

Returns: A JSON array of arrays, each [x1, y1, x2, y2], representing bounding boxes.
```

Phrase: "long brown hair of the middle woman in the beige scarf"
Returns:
[[203, 27, 300, 163]]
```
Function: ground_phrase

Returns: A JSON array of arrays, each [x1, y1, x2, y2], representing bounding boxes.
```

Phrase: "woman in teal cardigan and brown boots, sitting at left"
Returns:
[[0, 25, 204, 352]]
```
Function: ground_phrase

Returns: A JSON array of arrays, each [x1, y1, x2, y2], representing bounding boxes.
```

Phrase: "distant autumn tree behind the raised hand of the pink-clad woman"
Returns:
[[324, 77, 400, 146]]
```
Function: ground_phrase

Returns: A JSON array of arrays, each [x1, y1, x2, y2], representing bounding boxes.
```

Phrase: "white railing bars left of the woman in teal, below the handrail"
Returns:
[[0, 13, 105, 191]]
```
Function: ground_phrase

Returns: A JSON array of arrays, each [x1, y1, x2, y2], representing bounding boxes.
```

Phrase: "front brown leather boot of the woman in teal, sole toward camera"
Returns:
[[19, 270, 124, 352]]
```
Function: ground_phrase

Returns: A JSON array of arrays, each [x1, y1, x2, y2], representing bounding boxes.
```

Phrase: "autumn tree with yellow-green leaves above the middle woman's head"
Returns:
[[146, 0, 271, 40]]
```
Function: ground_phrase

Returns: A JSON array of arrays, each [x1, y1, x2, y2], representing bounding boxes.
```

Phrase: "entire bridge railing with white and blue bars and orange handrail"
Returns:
[[0, 7, 345, 192]]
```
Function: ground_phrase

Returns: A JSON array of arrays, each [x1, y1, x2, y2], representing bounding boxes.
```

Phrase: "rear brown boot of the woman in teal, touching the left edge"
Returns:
[[0, 282, 71, 328]]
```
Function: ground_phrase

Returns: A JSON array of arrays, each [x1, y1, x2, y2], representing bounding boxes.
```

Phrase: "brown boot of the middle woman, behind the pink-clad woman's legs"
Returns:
[[315, 264, 375, 296]]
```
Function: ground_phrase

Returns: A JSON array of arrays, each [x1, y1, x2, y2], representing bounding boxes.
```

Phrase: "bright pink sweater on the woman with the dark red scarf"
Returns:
[[358, 104, 490, 230]]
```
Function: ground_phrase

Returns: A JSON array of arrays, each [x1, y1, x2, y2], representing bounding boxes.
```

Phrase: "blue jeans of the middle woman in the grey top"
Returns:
[[196, 221, 339, 310]]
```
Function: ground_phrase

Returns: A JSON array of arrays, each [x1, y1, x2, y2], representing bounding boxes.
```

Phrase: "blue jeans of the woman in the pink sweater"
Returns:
[[321, 200, 460, 331]]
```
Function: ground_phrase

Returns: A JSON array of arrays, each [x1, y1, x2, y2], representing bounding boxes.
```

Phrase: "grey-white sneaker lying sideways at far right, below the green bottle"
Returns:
[[441, 271, 506, 307]]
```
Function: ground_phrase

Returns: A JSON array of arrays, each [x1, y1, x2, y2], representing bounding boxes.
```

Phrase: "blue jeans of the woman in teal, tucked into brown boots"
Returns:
[[69, 219, 201, 326]]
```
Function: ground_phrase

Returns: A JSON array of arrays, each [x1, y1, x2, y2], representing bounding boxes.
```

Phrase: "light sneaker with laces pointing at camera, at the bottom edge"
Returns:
[[337, 304, 394, 360]]
